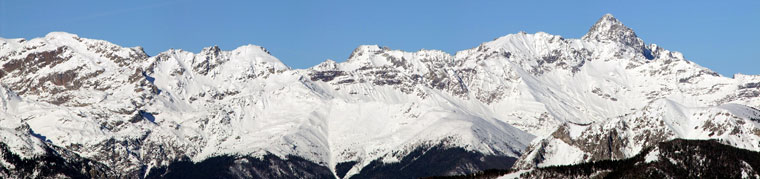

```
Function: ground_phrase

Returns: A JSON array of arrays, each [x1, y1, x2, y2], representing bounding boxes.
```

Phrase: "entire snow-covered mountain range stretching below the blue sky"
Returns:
[[0, 14, 760, 178]]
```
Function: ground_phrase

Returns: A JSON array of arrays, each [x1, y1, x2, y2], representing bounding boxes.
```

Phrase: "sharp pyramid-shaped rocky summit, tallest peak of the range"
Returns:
[[583, 14, 644, 47]]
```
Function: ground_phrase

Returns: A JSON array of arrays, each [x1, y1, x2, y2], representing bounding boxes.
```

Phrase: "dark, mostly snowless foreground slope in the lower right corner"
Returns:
[[424, 139, 760, 179]]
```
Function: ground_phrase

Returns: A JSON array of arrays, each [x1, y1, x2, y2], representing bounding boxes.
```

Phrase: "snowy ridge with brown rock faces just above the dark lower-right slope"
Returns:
[[515, 99, 760, 169]]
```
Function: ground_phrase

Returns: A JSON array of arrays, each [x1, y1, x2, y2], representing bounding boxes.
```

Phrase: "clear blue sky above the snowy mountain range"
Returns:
[[0, 0, 760, 76]]
